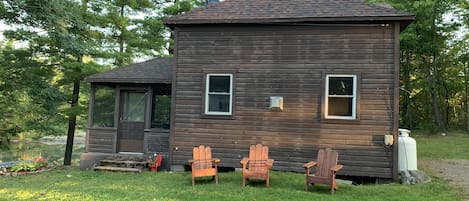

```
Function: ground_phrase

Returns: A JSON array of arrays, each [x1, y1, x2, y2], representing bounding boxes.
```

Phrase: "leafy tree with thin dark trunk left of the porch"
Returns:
[[1, 0, 102, 165]]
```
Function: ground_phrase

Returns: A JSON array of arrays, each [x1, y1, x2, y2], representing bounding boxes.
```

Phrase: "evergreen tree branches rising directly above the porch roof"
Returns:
[[88, 0, 165, 66]]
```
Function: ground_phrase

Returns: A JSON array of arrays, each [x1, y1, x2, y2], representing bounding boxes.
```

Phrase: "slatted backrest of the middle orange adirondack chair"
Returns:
[[248, 144, 269, 172]]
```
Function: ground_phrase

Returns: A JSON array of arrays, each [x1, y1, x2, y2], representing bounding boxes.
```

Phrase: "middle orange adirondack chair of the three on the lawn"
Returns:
[[241, 144, 274, 187]]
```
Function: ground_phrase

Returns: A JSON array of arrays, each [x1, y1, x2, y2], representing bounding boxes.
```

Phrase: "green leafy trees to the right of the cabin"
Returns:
[[372, 0, 469, 132]]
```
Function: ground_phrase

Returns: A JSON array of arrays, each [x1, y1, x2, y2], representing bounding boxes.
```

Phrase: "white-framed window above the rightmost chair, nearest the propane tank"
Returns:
[[324, 75, 357, 119]]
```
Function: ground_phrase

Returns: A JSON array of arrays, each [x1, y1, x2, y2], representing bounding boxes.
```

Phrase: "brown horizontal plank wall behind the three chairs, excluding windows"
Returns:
[[171, 25, 394, 178]]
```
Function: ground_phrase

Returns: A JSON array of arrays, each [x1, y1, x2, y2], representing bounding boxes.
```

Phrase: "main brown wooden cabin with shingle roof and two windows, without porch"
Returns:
[[165, 0, 414, 178]]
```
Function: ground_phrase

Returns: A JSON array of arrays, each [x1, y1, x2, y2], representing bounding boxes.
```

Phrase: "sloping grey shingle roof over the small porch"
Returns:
[[85, 58, 173, 84]]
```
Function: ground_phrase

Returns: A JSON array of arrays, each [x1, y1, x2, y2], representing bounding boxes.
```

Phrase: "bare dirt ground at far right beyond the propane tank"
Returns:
[[418, 159, 469, 201]]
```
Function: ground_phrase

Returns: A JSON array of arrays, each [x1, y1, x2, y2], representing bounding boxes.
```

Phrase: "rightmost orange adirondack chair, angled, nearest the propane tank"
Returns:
[[303, 148, 344, 193]]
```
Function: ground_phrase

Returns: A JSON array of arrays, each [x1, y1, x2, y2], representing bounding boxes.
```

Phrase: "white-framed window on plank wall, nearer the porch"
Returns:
[[205, 74, 233, 115]]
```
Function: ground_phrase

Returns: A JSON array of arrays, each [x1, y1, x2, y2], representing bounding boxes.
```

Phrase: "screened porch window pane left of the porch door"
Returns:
[[92, 86, 115, 127]]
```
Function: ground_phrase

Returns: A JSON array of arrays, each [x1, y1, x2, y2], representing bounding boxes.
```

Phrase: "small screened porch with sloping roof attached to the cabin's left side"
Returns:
[[80, 58, 173, 169]]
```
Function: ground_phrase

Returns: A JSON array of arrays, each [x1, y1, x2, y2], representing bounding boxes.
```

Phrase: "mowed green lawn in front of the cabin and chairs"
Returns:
[[0, 168, 460, 201]]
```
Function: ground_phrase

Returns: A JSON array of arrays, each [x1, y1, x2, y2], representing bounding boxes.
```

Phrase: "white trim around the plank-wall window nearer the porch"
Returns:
[[204, 73, 234, 116]]
